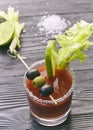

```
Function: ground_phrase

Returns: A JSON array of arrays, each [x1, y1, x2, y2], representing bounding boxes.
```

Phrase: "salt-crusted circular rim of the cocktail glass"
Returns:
[[24, 59, 74, 104]]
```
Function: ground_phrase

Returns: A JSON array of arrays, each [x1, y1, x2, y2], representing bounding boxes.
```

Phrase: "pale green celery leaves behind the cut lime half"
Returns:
[[0, 7, 24, 53]]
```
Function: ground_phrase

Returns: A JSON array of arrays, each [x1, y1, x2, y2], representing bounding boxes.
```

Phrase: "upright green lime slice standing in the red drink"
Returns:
[[45, 40, 57, 77]]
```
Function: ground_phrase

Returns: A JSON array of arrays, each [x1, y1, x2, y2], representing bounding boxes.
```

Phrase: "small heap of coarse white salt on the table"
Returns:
[[37, 14, 71, 35]]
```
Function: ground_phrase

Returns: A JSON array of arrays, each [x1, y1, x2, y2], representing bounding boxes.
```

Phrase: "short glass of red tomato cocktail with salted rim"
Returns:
[[25, 60, 73, 126]]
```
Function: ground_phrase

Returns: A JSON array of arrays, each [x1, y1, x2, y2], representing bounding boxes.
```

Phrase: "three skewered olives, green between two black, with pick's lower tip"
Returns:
[[26, 68, 57, 105]]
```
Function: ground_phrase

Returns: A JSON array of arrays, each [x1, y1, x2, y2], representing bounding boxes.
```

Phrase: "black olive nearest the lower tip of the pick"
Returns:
[[40, 84, 54, 97]]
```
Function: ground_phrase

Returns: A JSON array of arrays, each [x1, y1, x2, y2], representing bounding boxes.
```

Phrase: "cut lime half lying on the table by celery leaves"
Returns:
[[0, 21, 14, 46]]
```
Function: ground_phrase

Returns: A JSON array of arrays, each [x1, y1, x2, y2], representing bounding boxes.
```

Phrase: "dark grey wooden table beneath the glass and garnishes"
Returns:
[[0, 0, 93, 130]]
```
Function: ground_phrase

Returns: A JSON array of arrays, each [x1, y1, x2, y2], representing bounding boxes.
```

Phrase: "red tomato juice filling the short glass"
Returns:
[[26, 66, 73, 118]]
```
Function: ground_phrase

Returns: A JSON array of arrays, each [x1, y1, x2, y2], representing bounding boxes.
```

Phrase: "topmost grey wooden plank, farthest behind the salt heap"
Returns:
[[0, 0, 93, 16]]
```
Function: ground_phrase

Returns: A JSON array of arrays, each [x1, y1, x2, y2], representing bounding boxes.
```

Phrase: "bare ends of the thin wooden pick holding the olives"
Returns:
[[7, 50, 57, 105]]
